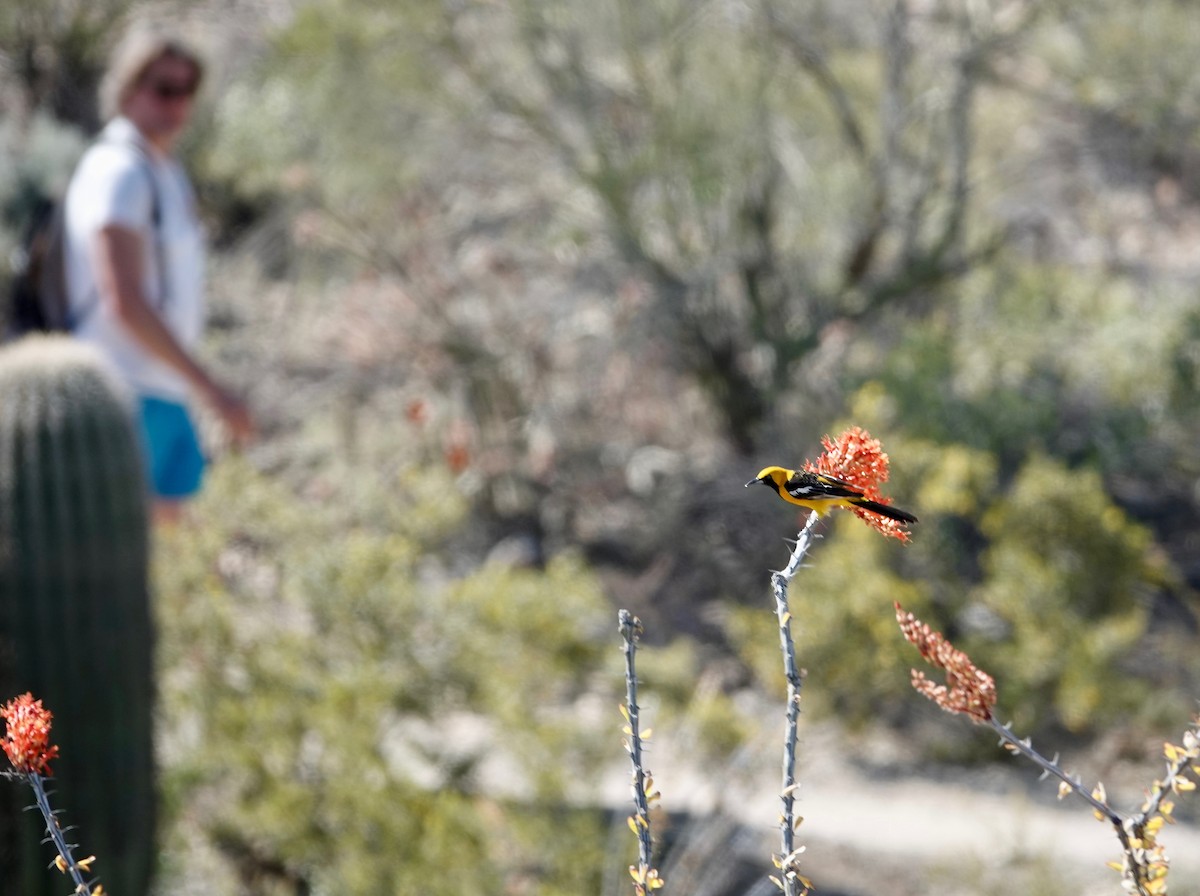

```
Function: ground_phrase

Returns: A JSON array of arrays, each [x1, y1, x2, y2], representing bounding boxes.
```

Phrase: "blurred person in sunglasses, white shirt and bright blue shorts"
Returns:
[[65, 30, 253, 522]]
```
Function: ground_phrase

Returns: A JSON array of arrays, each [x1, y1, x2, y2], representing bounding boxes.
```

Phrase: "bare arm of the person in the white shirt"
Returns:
[[94, 224, 253, 443]]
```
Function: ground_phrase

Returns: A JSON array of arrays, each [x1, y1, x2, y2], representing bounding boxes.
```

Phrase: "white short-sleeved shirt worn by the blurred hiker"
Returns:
[[65, 118, 205, 402]]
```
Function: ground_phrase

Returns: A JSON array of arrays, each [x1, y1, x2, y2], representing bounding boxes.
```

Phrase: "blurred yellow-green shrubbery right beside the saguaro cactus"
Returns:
[[157, 463, 617, 895]]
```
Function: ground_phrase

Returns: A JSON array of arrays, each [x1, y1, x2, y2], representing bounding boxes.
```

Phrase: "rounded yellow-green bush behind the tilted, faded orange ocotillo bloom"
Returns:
[[962, 457, 1164, 730]]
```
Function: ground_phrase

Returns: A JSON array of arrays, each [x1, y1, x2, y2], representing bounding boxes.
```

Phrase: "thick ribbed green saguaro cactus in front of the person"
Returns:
[[0, 336, 156, 896]]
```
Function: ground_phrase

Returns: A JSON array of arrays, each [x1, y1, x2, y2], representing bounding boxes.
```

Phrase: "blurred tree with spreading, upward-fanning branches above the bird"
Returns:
[[444, 0, 1043, 451]]
